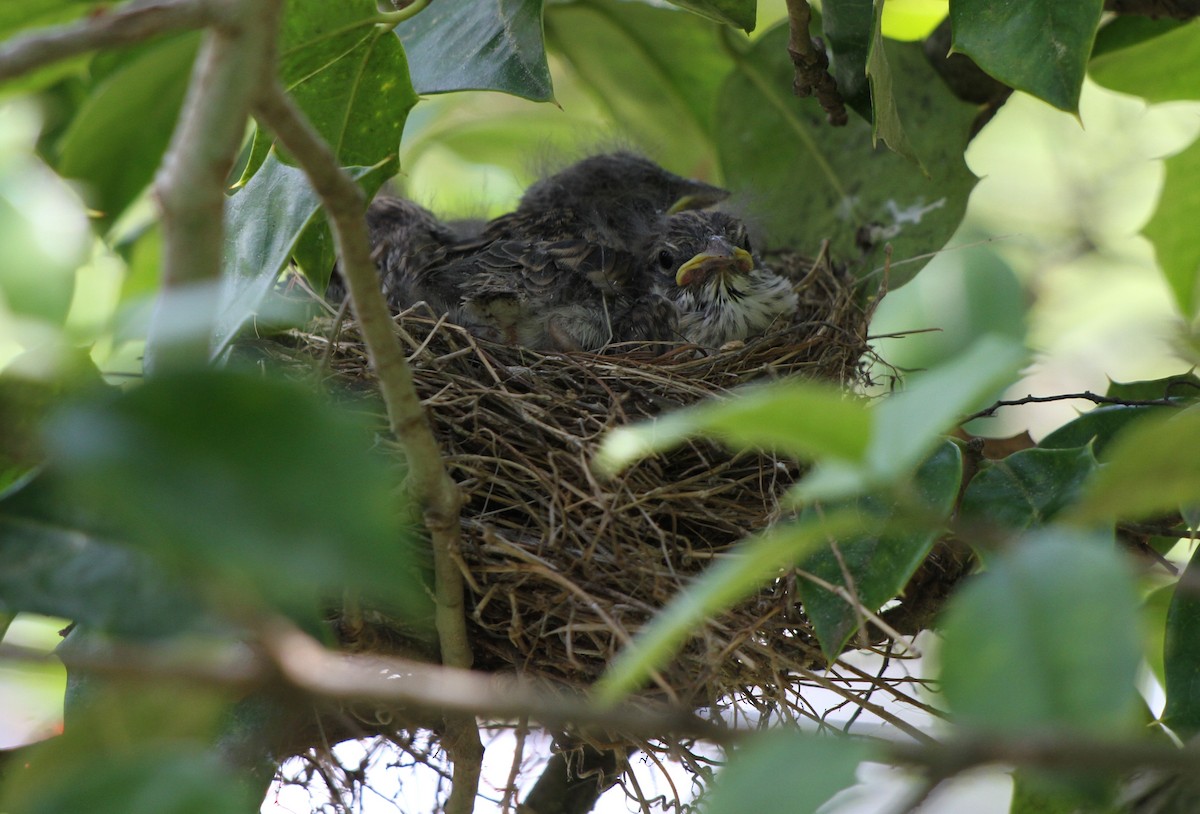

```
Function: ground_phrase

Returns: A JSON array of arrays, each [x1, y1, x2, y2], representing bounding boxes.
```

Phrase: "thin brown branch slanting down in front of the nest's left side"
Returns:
[[256, 79, 484, 814]]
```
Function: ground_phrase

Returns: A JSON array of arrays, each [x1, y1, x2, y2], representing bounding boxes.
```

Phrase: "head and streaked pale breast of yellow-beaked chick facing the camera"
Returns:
[[643, 211, 799, 348]]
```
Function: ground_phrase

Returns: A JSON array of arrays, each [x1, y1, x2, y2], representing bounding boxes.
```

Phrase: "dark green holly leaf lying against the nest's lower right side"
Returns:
[[797, 441, 962, 659]]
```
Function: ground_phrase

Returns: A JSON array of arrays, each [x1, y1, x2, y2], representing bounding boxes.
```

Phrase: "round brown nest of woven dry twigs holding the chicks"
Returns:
[[265, 250, 902, 708]]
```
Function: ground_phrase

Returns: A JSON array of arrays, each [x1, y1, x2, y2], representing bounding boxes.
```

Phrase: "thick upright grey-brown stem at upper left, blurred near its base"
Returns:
[[144, 0, 280, 372]]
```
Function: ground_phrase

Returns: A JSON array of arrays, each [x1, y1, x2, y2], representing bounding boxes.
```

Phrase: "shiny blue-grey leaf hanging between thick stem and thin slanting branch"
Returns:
[[214, 154, 382, 355]]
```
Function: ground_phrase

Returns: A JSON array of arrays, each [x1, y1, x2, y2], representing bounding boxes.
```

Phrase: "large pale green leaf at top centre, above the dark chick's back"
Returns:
[[546, 0, 733, 170]]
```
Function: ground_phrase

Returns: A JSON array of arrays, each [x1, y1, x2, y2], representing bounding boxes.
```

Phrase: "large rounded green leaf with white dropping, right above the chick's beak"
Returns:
[[716, 25, 977, 288]]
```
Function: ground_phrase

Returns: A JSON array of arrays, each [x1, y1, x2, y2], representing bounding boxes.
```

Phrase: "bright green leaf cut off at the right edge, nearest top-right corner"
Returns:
[[1088, 17, 1200, 102]]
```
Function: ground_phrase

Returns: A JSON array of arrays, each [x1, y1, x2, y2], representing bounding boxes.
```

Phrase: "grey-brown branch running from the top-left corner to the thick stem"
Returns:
[[0, 0, 208, 82]]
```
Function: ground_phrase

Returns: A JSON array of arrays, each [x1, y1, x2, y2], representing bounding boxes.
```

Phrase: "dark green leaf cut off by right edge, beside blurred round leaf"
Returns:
[[1163, 552, 1200, 738]]
